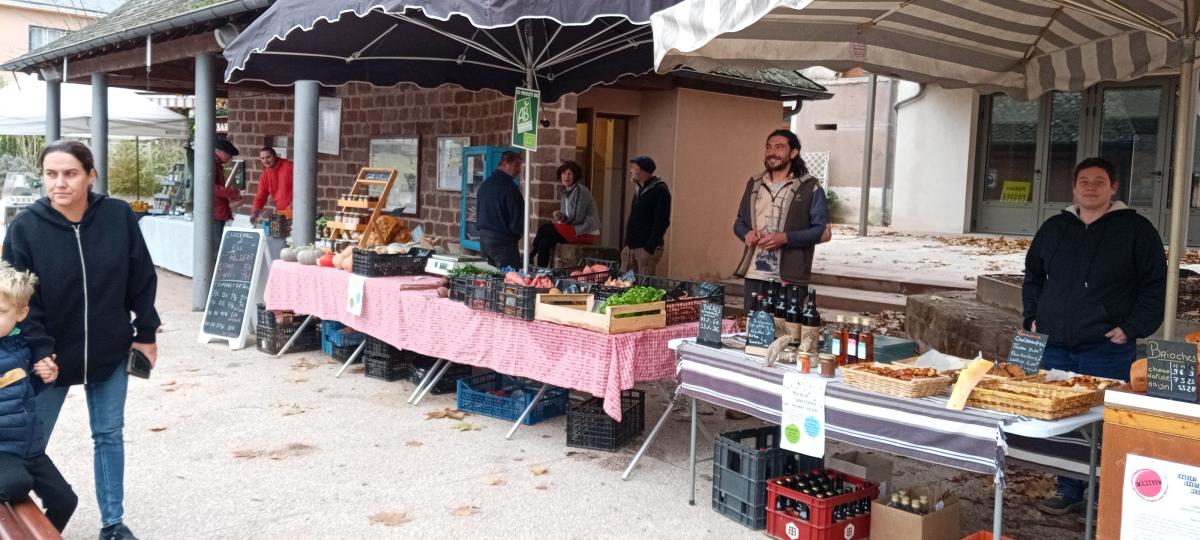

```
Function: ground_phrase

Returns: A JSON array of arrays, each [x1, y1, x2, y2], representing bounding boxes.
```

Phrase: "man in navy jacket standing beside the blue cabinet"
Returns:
[[475, 151, 524, 269]]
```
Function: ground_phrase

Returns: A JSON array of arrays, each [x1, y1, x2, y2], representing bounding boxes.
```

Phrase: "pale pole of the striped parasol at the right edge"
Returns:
[[1163, 0, 1200, 340]]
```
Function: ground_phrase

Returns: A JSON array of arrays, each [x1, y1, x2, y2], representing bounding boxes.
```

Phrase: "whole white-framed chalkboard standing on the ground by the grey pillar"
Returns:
[[199, 229, 265, 349]]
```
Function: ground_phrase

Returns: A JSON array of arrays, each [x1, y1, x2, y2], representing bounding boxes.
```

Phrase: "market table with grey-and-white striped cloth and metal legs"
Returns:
[[672, 340, 1103, 538]]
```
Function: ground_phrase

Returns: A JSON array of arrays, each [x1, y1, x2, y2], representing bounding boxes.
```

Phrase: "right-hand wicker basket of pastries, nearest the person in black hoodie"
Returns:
[[967, 380, 1104, 420]]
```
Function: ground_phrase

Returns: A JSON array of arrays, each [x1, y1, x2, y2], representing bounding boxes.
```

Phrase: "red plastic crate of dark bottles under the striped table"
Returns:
[[767, 475, 880, 540]]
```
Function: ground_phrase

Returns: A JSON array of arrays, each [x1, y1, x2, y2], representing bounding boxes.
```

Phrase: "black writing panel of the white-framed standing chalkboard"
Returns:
[[203, 230, 263, 338]]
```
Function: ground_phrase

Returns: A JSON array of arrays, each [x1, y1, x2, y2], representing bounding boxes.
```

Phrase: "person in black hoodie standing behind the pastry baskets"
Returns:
[[1021, 157, 1166, 514]]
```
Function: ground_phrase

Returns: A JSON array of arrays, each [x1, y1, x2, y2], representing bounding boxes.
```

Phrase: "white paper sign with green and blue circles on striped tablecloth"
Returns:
[[780, 372, 826, 457]]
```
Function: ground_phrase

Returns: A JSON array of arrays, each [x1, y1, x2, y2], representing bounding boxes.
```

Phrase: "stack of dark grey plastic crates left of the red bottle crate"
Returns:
[[713, 426, 823, 530]]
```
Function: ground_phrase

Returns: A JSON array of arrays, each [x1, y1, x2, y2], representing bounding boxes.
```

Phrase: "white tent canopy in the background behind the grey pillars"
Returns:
[[0, 76, 190, 139]]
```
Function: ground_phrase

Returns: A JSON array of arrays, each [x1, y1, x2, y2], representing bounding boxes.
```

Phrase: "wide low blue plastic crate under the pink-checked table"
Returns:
[[456, 373, 570, 426]]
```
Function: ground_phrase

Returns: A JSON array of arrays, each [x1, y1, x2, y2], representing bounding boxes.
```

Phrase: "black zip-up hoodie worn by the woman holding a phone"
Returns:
[[4, 193, 160, 386]]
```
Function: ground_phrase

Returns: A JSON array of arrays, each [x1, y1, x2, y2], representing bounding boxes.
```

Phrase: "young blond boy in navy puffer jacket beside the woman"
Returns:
[[0, 262, 79, 533]]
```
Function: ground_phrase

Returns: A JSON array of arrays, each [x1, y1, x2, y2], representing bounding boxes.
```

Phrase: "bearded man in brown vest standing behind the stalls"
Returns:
[[733, 130, 832, 311]]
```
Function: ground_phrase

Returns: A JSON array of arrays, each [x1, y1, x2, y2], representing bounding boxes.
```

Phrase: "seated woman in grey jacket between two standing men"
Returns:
[[532, 161, 600, 268]]
